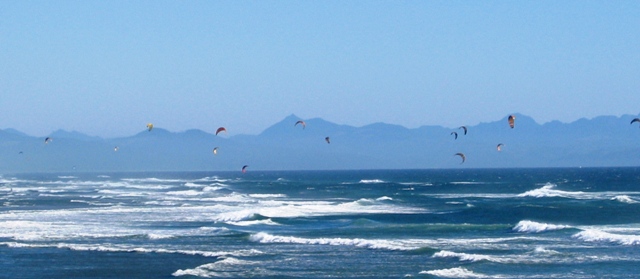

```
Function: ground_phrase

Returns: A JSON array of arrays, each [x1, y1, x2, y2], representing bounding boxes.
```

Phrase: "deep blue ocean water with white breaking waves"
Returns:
[[0, 168, 640, 278]]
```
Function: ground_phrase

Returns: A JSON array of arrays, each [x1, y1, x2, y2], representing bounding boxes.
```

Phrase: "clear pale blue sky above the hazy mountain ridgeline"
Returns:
[[0, 0, 640, 138]]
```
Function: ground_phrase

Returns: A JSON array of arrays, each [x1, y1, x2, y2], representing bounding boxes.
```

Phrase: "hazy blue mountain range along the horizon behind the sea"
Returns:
[[0, 114, 640, 173]]
